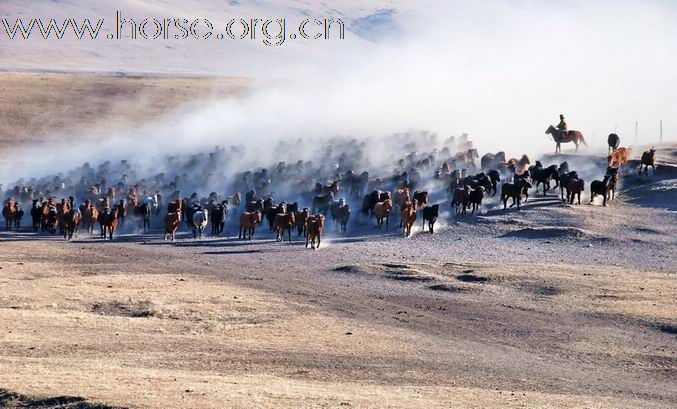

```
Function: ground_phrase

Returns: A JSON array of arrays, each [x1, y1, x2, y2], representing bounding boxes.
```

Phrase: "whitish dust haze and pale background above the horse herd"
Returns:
[[0, 1, 677, 180]]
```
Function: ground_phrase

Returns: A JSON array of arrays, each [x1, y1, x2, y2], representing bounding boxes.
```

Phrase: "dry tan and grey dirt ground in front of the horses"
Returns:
[[0, 74, 677, 409]]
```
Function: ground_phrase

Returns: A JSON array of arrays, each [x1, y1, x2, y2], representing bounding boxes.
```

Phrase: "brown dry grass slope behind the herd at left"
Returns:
[[0, 72, 248, 148]]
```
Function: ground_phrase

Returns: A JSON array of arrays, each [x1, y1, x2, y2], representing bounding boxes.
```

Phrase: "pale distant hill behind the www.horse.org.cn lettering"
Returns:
[[0, 0, 407, 76]]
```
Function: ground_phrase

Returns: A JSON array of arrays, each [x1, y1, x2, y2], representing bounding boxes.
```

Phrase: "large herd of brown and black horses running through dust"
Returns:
[[0, 131, 656, 249]]
